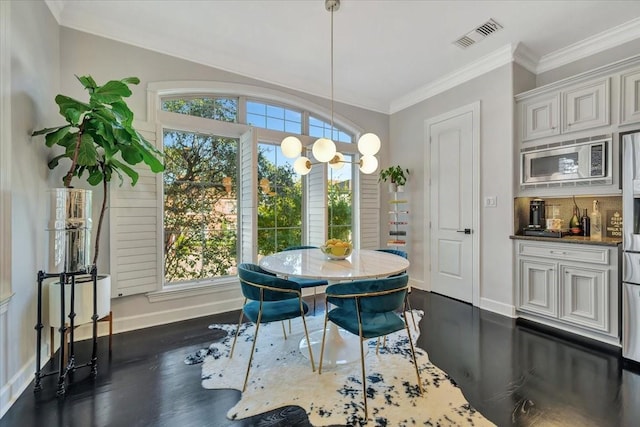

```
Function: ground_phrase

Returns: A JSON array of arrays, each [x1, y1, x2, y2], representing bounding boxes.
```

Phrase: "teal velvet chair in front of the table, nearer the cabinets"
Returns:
[[318, 274, 423, 418]]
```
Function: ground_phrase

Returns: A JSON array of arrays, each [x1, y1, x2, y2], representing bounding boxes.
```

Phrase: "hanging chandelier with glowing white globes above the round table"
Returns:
[[280, 0, 380, 175]]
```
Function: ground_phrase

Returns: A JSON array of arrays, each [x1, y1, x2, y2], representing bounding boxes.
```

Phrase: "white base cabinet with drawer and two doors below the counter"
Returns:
[[515, 240, 620, 346]]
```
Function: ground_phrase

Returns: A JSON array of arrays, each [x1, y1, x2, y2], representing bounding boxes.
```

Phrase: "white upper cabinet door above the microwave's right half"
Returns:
[[562, 78, 611, 133]]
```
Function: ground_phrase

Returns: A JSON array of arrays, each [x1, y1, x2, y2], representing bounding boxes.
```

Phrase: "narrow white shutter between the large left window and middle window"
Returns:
[[238, 129, 258, 263]]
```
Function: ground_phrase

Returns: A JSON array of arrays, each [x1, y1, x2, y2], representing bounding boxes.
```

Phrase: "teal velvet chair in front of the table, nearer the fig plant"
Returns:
[[234, 263, 316, 391]]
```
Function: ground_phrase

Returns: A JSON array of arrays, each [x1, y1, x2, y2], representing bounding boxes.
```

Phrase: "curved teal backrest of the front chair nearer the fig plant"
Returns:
[[238, 263, 300, 301]]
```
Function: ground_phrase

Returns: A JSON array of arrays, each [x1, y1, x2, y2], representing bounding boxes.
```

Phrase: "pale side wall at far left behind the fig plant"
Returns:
[[0, 1, 60, 415]]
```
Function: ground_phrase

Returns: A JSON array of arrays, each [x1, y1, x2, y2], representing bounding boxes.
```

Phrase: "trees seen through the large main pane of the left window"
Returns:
[[164, 131, 238, 283]]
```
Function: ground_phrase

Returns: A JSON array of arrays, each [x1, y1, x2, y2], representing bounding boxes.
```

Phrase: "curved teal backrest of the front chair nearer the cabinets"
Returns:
[[325, 274, 409, 313]]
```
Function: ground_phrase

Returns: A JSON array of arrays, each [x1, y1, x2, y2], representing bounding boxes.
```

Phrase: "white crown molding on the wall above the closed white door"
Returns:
[[389, 44, 513, 114]]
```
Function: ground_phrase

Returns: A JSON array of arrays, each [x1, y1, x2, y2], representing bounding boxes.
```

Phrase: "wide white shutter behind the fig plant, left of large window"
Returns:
[[109, 123, 164, 297]]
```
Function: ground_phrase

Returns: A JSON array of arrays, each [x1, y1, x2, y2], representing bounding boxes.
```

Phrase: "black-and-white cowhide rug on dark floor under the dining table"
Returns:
[[185, 310, 493, 426]]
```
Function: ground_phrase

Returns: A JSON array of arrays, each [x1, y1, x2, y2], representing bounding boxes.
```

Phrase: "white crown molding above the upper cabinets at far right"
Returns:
[[536, 18, 640, 74]]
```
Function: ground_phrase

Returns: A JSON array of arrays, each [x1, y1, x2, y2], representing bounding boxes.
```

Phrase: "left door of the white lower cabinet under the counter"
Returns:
[[518, 258, 558, 317]]
